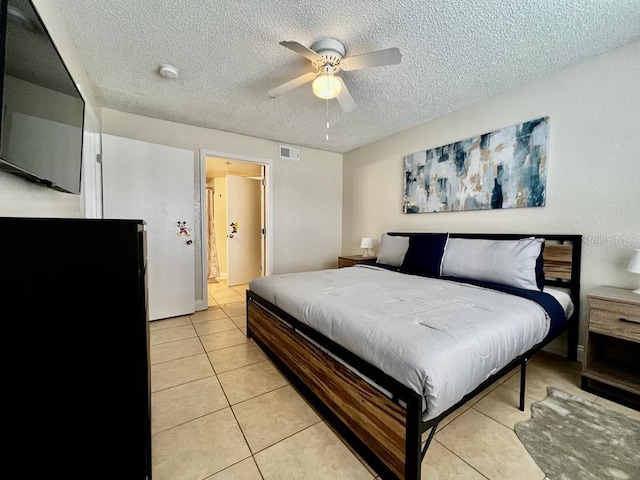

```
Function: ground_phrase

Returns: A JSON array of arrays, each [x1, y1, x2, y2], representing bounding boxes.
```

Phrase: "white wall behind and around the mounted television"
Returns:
[[0, 0, 100, 217]]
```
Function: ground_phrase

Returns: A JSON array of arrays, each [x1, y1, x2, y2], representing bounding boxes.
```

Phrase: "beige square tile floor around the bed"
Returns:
[[150, 284, 640, 480]]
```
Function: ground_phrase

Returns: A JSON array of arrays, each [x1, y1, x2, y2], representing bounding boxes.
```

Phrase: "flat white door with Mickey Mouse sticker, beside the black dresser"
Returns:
[[97, 135, 195, 320]]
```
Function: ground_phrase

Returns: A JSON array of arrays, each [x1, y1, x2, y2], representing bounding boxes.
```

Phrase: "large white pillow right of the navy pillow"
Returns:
[[442, 237, 544, 291]]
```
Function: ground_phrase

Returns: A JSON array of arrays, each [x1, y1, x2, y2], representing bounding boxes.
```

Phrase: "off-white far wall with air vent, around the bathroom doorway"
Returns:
[[102, 109, 342, 284]]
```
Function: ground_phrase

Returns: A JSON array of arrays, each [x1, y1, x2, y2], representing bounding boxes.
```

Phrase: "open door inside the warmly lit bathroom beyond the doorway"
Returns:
[[227, 175, 263, 286]]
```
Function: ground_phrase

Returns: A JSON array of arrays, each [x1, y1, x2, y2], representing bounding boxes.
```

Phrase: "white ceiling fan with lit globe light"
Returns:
[[268, 38, 402, 112]]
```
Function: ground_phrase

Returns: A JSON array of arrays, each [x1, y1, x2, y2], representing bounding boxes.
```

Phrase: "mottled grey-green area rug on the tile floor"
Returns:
[[515, 387, 640, 480]]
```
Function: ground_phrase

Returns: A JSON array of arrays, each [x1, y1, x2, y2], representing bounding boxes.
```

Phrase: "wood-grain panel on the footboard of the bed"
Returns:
[[248, 302, 406, 479]]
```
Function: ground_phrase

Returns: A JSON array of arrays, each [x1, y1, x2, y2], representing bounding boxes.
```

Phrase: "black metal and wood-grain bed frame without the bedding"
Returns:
[[247, 233, 582, 480]]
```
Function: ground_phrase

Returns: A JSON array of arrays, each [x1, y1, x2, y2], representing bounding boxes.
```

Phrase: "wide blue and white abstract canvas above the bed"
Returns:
[[403, 117, 549, 213]]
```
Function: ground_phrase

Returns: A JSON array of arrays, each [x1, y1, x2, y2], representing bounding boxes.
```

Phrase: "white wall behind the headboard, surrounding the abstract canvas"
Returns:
[[342, 38, 640, 356]]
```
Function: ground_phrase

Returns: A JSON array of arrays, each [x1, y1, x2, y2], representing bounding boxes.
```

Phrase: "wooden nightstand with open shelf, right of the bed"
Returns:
[[582, 287, 640, 407]]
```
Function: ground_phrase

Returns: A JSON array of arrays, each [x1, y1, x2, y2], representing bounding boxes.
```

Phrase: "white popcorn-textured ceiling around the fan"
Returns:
[[50, 0, 640, 153]]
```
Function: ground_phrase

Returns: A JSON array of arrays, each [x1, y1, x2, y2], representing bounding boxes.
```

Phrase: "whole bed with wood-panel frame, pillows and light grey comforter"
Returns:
[[247, 232, 581, 480]]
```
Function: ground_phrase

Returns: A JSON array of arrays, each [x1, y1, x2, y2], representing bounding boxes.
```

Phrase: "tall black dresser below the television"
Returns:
[[0, 218, 151, 480]]
